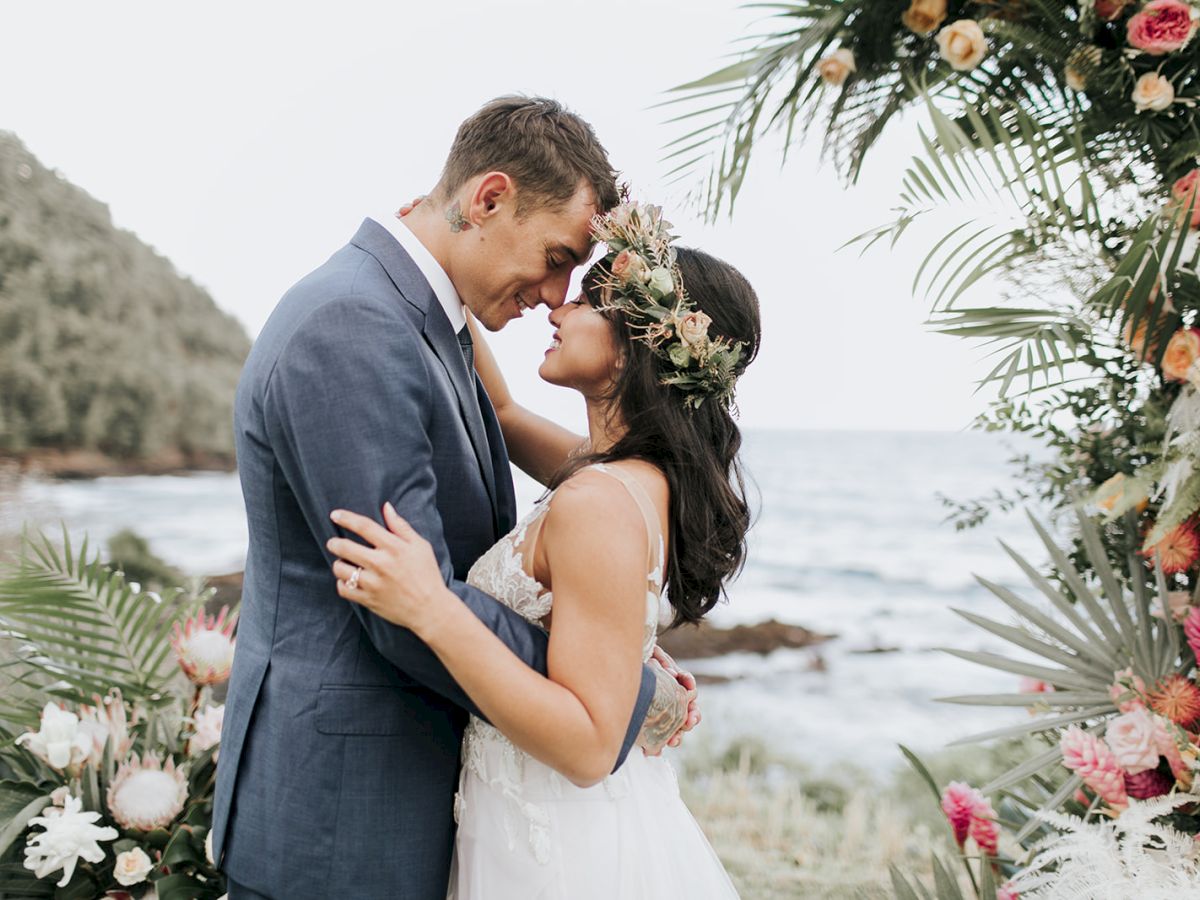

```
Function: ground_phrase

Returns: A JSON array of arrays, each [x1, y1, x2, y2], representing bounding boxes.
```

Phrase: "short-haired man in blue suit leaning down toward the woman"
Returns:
[[212, 97, 686, 900]]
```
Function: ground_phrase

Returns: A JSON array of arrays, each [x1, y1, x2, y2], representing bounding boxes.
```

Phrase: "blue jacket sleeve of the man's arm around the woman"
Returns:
[[263, 296, 654, 766]]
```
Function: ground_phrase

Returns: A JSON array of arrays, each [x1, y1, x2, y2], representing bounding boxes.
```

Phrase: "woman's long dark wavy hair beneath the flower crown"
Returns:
[[551, 247, 761, 628]]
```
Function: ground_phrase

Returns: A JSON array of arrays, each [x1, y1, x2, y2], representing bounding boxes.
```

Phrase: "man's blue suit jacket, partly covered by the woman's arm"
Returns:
[[212, 220, 653, 900]]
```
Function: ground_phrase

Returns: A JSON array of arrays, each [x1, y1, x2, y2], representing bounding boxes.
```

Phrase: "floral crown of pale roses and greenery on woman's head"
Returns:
[[589, 203, 745, 408]]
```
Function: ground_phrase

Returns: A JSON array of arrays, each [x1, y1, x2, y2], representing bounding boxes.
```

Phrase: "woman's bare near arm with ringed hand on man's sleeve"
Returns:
[[330, 473, 657, 786]]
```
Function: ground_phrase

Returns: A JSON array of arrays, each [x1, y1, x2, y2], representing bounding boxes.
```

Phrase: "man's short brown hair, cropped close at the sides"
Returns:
[[438, 96, 619, 215]]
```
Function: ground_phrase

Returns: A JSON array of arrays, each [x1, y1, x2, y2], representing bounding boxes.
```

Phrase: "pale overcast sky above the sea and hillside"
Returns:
[[0, 0, 1003, 430]]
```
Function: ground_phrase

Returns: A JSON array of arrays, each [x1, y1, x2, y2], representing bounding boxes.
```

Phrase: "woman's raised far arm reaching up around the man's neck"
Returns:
[[467, 314, 586, 485]]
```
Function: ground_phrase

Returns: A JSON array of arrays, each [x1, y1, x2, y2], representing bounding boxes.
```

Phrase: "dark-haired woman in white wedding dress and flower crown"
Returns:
[[329, 204, 760, 900]]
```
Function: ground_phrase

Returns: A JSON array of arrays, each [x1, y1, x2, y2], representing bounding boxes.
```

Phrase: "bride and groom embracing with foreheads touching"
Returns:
[[212, 97, 760, 900]]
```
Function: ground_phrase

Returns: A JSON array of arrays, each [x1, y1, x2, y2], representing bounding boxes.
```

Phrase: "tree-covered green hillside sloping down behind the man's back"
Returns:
[[0, 132, 250, 458]]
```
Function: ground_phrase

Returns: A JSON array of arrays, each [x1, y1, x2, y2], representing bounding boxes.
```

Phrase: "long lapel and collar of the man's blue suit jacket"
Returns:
[[350, 218, 508, 536]]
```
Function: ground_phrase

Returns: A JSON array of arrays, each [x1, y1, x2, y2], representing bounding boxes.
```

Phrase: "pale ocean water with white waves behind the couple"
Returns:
[[0, 431, 1045, 772]]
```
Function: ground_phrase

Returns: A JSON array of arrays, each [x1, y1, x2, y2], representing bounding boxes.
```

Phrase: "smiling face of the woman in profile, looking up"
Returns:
[[538, 292, 620, 397]]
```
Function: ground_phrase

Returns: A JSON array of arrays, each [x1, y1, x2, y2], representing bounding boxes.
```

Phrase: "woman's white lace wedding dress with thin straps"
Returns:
[[450, 464, 737, 900]]
